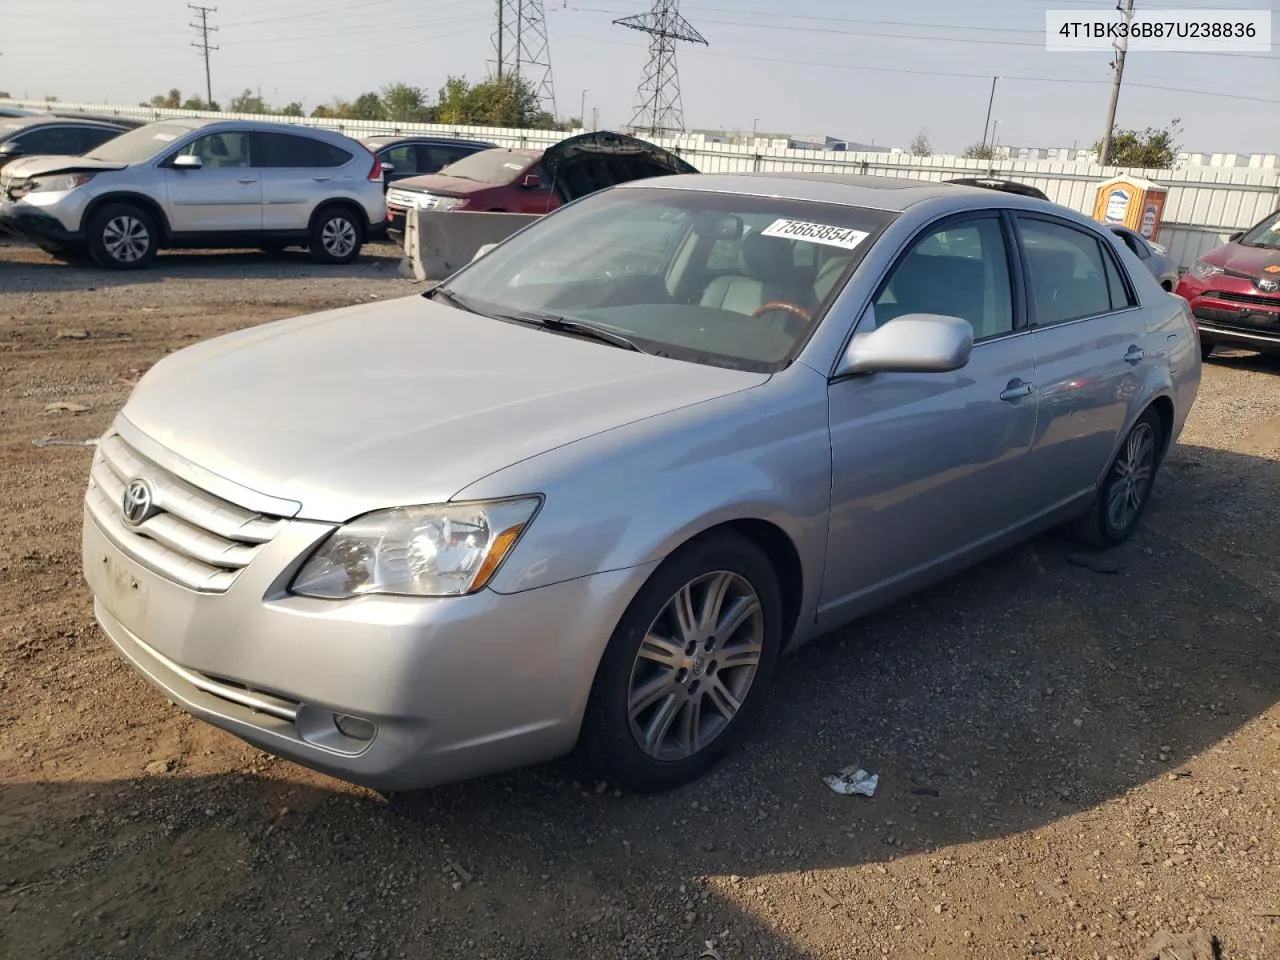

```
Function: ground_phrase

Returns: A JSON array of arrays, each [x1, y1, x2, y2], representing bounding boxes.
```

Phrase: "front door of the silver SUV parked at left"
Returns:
[[163, 131, 262, 233]]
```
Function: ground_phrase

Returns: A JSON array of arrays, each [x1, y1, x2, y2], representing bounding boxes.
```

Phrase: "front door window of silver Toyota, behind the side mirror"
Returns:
[[872, 215, 1014, 340]]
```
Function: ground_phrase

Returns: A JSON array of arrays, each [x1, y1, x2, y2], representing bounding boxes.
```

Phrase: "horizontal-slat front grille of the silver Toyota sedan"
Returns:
[[84, 434, 285, 593]]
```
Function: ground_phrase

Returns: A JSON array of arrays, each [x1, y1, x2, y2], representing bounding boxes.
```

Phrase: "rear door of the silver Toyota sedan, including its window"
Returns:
[[1015, 212, 1157, 503]]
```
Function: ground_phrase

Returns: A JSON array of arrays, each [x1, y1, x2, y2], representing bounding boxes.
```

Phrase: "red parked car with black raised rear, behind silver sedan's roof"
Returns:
[[387, 131, 698, 232]]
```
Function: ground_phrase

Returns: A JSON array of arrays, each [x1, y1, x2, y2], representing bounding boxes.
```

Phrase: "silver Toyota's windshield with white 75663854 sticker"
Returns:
[[443, 188, 893, 372]]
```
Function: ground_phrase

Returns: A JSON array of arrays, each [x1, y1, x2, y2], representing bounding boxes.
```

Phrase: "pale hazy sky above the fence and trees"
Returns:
[[0, 0, 1280, 154]]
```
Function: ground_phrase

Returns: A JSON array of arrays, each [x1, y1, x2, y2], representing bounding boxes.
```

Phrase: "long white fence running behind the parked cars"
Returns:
[[0, 101, 1280, 268]]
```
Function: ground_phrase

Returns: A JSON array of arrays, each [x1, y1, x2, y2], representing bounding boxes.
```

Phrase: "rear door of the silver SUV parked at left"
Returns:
[[252, 132, 352, 233]]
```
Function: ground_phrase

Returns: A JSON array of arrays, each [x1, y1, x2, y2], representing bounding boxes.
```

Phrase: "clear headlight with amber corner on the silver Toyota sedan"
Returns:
[[289, 497, 541, 600]]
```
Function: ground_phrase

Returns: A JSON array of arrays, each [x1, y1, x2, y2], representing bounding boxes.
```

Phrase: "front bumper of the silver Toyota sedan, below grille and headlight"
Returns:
[[83, 509, 653, 790]]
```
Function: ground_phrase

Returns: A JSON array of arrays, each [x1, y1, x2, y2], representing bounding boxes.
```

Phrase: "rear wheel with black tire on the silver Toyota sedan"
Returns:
[[1071, 407, 1165, 549]]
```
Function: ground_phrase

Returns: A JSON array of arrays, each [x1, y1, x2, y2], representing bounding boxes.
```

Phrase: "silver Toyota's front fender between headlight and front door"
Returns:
[[454, 365, 831, 617]]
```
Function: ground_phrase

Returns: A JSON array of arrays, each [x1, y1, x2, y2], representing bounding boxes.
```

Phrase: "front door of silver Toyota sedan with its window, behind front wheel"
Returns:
[[819, 212, 1038, 620]]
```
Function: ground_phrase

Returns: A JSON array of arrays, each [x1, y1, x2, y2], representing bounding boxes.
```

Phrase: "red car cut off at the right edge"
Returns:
[[1178, 210, 1280, 357]]
